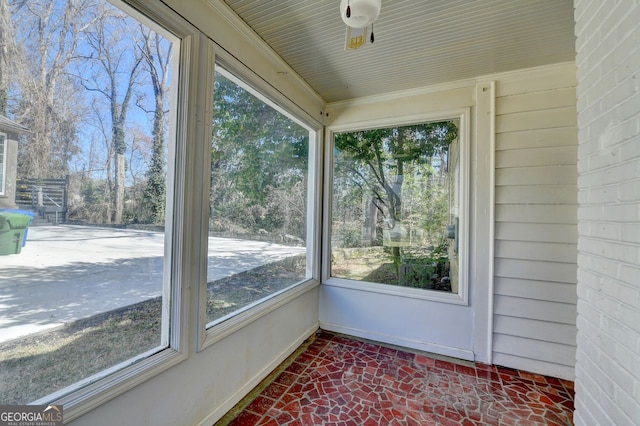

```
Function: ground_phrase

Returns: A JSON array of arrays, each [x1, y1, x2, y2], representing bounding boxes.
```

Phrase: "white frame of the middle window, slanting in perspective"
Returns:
[[197, 48, 323, 351]]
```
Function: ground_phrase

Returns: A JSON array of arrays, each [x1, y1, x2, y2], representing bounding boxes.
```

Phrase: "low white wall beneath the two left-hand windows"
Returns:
[[70, 288, 318, 426]]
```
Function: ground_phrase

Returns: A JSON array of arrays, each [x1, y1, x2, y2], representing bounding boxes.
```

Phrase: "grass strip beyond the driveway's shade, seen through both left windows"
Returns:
[[0, 256, 306, 404]]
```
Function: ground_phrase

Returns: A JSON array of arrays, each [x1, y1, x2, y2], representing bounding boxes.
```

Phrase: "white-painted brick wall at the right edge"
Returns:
[[574, 0, 640, 425]]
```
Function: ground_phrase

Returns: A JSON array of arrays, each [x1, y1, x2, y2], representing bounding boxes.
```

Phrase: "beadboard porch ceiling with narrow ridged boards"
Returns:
[[224, 0, 575, 103]]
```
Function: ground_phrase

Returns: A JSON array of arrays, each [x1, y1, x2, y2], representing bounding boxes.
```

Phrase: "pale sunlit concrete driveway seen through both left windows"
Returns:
[[0, 225, 305, 342]]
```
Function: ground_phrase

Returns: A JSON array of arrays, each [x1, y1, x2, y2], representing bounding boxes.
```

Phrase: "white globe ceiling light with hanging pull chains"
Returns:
[[340, 0, 382, 50]]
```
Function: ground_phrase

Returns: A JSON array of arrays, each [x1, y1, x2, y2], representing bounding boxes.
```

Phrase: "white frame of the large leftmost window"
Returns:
[[26, 0, 202, 421]]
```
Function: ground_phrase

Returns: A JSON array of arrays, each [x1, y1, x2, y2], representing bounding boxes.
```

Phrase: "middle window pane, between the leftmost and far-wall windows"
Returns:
[[207, 70, 309, 325]]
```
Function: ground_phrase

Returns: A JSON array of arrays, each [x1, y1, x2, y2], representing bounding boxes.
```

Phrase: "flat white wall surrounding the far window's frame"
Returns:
[[320, 81, 491, 360]]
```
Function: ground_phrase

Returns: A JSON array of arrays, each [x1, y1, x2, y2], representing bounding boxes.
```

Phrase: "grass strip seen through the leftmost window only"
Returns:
[[0, 298, 161, 404]]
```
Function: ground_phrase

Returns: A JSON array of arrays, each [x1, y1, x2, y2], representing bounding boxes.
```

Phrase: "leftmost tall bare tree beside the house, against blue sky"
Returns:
[[7, 0, 100, 177]]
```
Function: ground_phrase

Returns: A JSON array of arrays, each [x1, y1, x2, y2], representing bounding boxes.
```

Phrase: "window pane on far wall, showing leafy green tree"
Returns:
[[331, 121, 459, 293]]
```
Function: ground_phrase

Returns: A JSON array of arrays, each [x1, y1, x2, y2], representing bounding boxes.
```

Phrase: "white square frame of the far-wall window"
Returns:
[[322, 108, 471, 305]]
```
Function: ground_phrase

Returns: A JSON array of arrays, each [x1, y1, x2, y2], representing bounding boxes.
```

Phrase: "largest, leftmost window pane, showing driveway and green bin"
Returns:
[[0, 0, 179, 404]]
